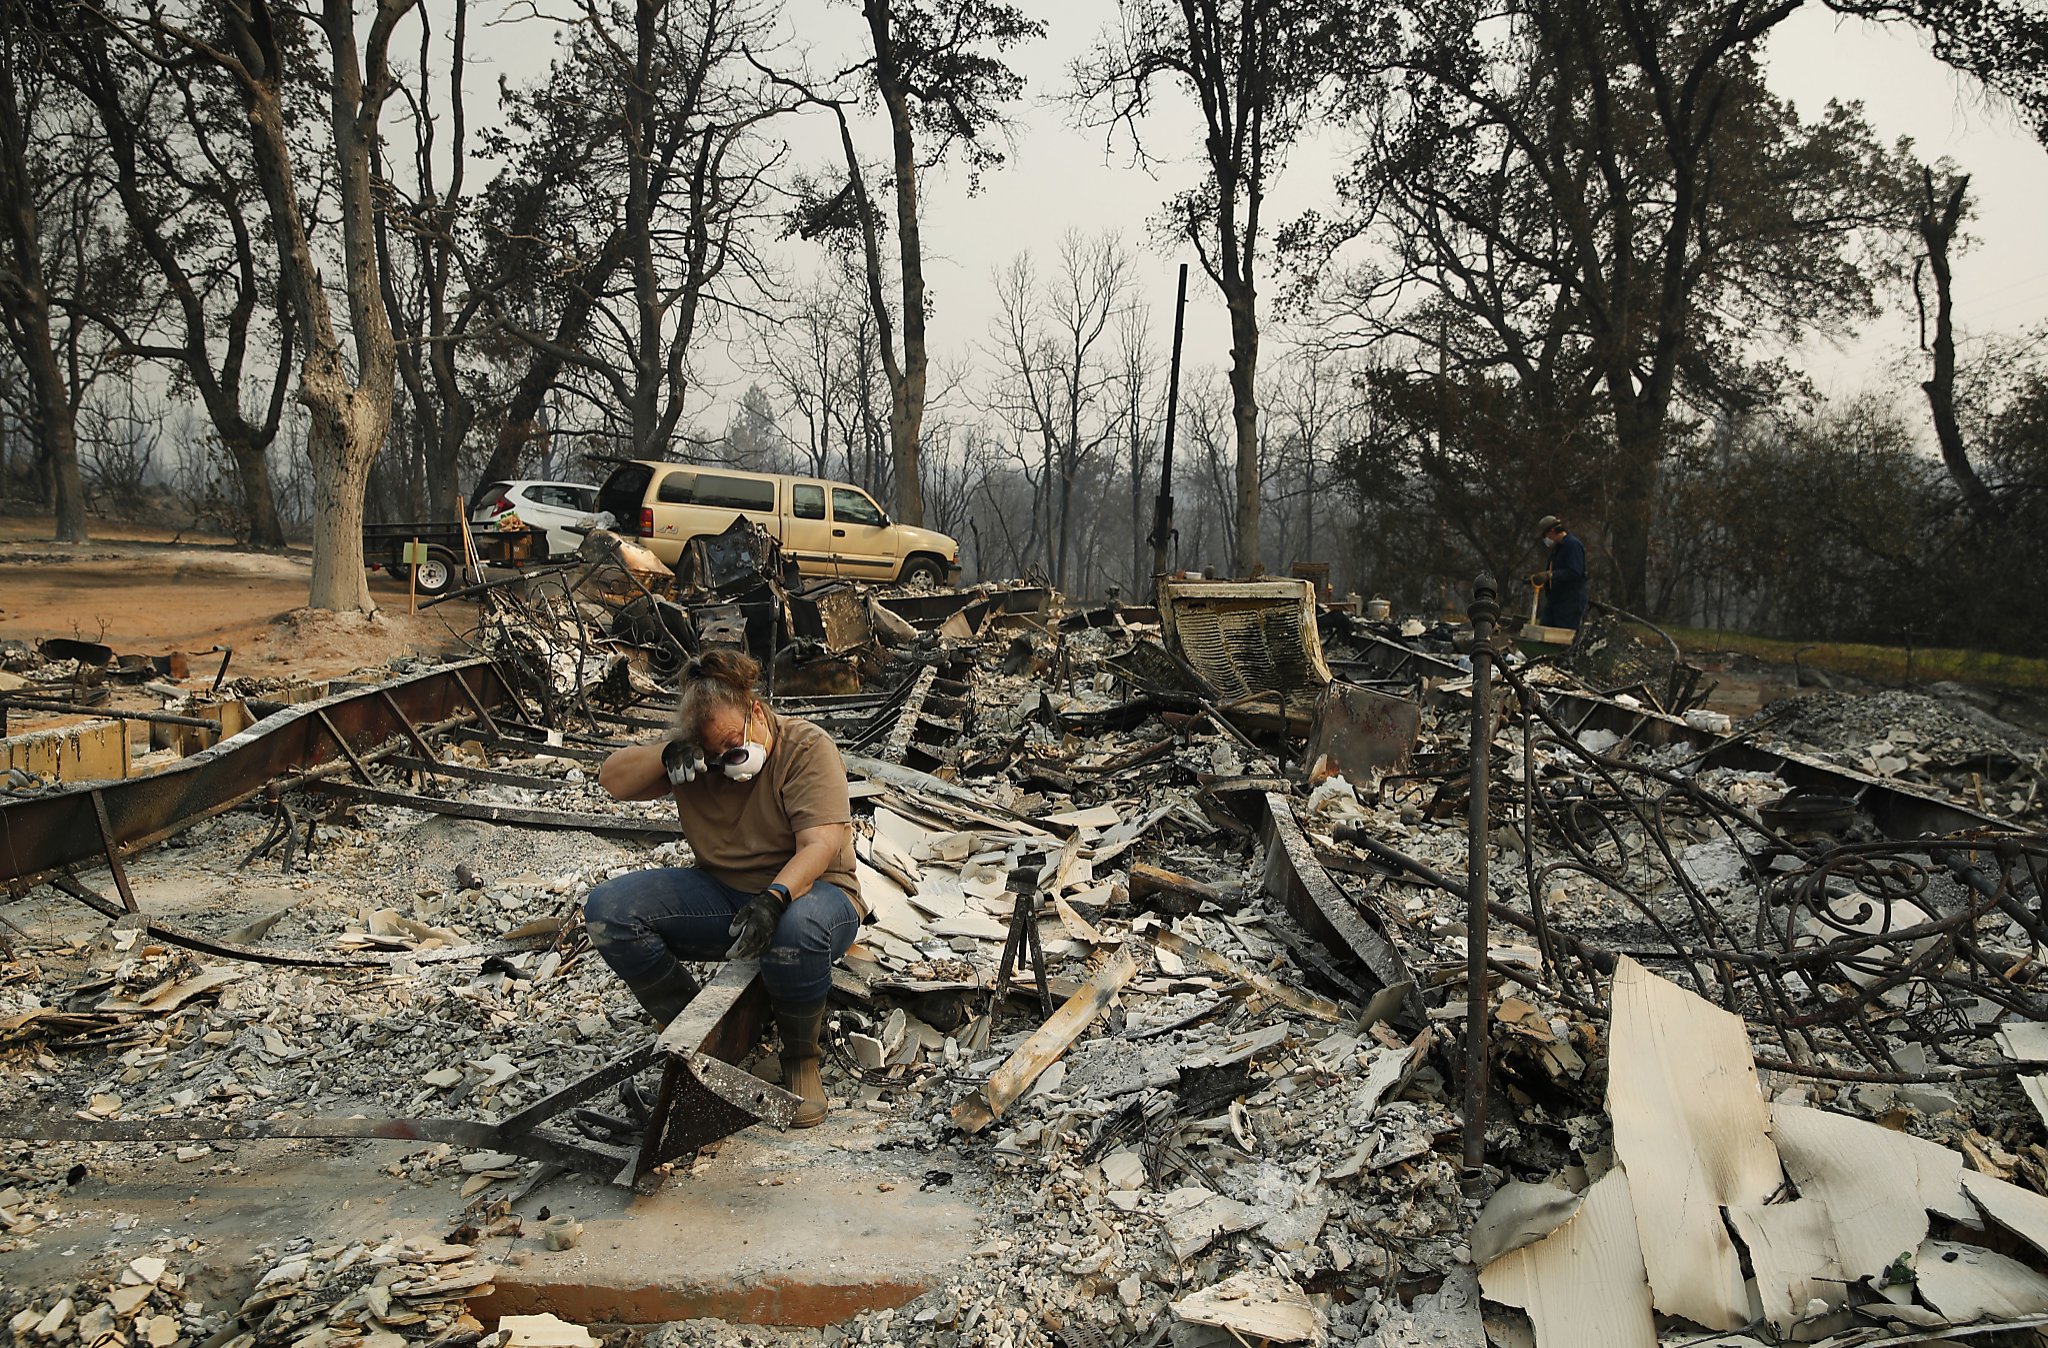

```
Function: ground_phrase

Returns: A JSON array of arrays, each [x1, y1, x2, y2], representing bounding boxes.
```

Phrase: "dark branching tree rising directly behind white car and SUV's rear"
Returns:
[[485, 0, 778, 471]]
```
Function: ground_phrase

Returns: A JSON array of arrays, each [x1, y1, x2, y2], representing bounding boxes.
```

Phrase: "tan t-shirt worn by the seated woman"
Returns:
[[676, 711, 868, 918]]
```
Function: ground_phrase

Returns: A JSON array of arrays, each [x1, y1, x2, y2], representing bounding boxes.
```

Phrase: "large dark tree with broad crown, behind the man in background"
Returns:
[[1341, 0, 1905, 606]]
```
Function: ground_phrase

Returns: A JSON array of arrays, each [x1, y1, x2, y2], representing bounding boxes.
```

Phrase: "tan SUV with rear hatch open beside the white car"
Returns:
[[598, 459, 961, 586]]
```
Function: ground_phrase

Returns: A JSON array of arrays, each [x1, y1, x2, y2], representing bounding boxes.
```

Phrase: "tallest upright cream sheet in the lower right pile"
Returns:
[[1608, 957, 1782, 1330]]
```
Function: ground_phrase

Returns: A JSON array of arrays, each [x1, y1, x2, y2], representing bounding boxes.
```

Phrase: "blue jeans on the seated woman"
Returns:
[[584, 867, 860, 1006]]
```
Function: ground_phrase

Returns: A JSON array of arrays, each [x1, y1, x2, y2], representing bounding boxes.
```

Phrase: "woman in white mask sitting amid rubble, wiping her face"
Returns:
[[584, 649, 862, 1127]]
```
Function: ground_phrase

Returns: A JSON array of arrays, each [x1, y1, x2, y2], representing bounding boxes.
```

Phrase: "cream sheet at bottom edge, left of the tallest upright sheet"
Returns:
[[1479, 1166, 1657, 1348]]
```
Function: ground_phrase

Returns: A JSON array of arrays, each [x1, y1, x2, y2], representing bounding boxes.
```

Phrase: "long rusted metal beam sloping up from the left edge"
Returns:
[[0, 660, 514, 893]]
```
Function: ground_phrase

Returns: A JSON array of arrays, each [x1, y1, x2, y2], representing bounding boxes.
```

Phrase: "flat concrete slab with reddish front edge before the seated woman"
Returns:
[[471, 1110, 983, 1328]]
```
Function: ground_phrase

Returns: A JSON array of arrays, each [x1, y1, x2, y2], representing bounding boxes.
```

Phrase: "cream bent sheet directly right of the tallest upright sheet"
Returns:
[[1772, 1104, 1980, 1280]]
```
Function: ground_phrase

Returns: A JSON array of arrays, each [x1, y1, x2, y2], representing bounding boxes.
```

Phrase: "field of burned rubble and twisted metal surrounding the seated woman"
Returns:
[[0, 526, 2048, 1348]]
